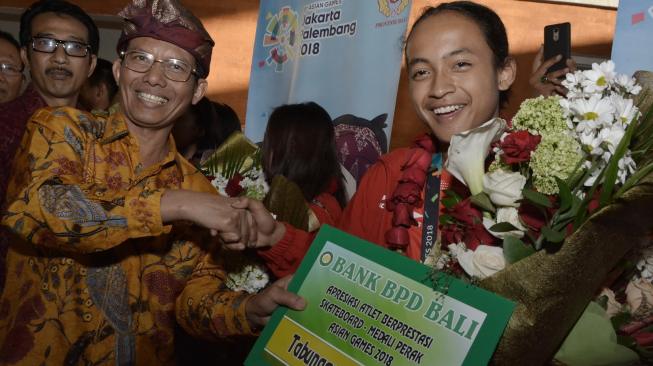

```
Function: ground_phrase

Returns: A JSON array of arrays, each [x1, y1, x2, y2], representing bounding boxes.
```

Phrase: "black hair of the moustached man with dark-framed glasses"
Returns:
[[20, 0, 100, 55]]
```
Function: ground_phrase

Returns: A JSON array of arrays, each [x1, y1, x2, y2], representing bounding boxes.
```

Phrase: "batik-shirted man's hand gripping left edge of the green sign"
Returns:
[[245, 276, 306, 329]]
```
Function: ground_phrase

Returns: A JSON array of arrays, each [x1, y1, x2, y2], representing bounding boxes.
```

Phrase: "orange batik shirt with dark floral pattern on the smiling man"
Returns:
[[0, 108, 251, 365]]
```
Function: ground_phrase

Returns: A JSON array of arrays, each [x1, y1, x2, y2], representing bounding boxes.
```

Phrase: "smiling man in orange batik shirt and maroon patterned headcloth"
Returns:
[[0, 0, 304, 365]]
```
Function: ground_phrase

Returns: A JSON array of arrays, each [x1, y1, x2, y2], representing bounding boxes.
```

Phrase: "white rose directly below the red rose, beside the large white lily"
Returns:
[[483, 169, 526, 207]]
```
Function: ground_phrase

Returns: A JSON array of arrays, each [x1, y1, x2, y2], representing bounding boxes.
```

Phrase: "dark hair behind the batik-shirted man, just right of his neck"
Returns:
[[190, 97, 240, 151]]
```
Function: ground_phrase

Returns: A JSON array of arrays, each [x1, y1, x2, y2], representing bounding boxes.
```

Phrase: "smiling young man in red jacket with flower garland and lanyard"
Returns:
[[242, 1, 517, 272]]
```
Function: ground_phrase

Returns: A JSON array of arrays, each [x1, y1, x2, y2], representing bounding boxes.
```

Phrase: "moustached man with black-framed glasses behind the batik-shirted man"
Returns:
[[0, 0, 99, 290]]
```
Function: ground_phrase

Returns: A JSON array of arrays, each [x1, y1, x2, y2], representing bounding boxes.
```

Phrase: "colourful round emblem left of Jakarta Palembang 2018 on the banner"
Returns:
[[258, 6, 300, 72]]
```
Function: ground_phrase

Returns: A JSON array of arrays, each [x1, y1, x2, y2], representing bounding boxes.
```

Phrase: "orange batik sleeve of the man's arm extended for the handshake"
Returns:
[[2, 108, 169, 253]]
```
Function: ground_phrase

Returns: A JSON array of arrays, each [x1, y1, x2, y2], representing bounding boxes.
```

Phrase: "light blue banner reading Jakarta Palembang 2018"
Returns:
[[245, 0, 411, 180]]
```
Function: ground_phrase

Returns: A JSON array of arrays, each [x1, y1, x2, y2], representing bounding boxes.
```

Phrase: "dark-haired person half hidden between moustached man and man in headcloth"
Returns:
[[79, 58, 118, 112]]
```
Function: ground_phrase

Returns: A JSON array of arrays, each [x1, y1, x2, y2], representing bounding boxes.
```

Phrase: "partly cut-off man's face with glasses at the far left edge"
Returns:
[[0, 30, 25, 103]]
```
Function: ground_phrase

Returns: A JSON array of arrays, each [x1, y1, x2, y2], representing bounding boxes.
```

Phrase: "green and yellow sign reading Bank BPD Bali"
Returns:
[[245, 226, 514, 366]]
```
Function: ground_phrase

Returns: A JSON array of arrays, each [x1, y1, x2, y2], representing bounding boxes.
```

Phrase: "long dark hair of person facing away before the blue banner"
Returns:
[[262, 102, 346, 206]]
